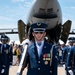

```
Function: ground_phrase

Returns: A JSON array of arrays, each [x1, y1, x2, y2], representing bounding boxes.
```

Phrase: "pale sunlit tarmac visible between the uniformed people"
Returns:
[[9, 66, 65, 75]]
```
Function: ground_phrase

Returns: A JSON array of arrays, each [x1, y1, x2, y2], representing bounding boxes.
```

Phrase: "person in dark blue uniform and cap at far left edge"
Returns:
[[0, 35, 13, 75]]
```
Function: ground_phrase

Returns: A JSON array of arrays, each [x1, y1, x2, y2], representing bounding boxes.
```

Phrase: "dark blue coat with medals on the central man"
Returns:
[[23, 42, 57, 75]]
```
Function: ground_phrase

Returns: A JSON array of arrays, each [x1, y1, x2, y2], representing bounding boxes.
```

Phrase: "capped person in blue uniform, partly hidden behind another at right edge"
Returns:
[[63, 37, 75, 75]]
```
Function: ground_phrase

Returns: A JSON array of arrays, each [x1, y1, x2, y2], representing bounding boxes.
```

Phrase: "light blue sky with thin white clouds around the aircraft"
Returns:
[[0, 0, 75, 43]]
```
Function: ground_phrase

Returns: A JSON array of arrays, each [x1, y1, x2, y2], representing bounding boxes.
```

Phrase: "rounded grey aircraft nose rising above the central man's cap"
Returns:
[[28, 0, 62, 29]]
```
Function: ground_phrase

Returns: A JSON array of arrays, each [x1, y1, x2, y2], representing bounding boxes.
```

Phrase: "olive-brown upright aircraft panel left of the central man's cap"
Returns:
[[18, 20, 30, 43]]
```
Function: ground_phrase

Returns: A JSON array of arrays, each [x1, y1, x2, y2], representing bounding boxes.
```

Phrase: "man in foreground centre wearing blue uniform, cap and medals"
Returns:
[[21, 23, 57, 75]]
